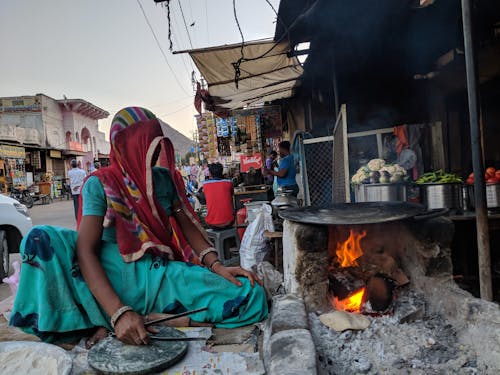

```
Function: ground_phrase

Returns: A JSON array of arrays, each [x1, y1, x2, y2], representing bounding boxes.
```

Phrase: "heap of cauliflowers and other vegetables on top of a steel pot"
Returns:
[[351, 159, 406, 185]]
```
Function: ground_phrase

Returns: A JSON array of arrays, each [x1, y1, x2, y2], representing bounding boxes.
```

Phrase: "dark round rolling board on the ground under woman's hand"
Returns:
[[88, 326, 188, 375]]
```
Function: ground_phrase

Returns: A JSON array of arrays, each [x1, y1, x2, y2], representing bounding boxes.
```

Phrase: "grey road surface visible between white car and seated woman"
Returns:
[[0, 200, 76, 301]]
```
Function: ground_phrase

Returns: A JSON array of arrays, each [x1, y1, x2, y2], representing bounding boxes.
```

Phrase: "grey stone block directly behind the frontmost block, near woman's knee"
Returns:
[[270, 294, 308, 335]]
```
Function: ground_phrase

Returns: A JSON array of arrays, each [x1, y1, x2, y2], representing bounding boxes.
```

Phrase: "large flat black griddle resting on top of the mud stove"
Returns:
[[280, 202, 425, 225]]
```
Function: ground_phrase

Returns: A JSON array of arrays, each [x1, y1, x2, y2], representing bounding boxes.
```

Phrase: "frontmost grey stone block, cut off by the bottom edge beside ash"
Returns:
[[267, 329, 317, 375]]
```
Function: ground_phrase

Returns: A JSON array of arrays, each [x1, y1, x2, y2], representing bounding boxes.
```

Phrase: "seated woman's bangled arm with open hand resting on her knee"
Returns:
[[173, 202, 262, 286]]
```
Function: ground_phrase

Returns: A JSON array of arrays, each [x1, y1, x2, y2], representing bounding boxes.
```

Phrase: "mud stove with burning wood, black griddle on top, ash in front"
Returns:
[[282, 203, 500, 374]]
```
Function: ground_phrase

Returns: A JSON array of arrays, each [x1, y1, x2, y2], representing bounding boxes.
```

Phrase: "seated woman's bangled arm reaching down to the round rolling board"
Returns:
[[76, 216, 149, 345]]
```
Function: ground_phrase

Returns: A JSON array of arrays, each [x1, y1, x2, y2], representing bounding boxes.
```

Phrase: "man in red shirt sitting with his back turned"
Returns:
[[203, 163, 234, 229]]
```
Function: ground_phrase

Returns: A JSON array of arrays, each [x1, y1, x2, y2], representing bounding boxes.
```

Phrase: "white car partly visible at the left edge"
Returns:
[[0, 194, 33, 281]]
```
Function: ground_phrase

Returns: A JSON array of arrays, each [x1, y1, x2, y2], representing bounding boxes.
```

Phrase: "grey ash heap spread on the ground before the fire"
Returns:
[[309, 290, 480, 375]]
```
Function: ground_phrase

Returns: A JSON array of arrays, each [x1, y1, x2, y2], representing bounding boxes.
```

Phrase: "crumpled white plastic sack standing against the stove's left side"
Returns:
[[240, 204, 274, 271]]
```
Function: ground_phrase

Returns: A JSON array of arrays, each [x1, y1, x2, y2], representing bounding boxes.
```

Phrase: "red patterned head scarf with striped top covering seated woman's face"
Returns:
[[78, 107, 201, 262]]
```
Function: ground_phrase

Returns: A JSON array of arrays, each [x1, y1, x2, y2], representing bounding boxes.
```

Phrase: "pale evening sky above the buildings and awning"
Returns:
[[0, 0, 279, 137]]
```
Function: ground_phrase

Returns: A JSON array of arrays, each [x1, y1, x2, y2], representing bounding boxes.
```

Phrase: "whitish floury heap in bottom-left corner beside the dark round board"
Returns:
[[0, 341, 72, 375]]
